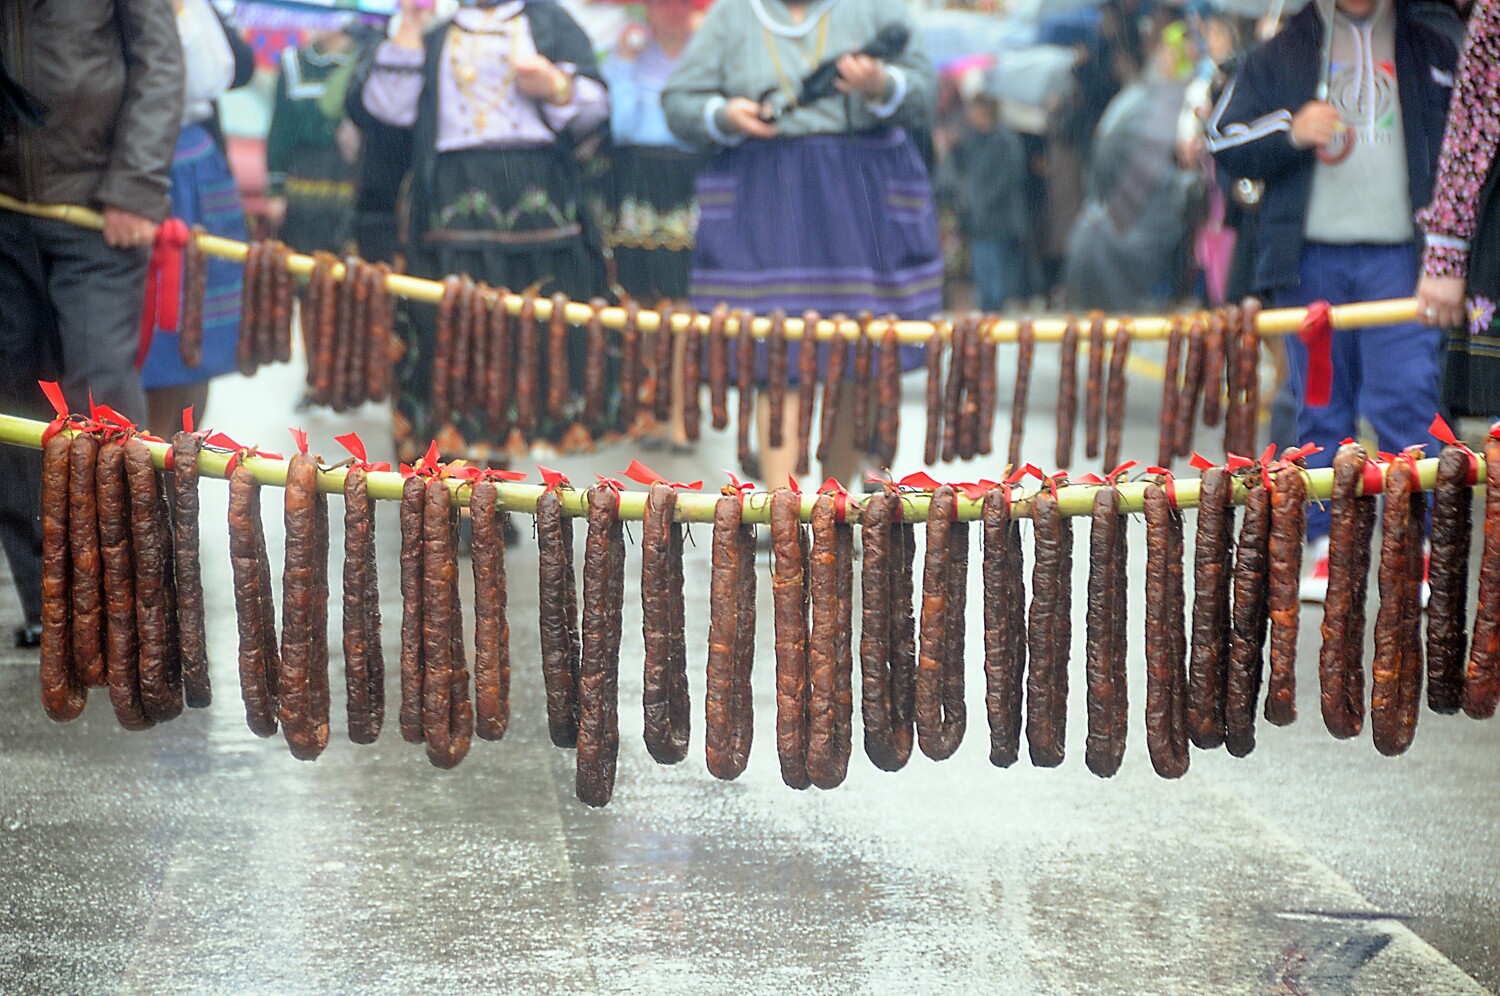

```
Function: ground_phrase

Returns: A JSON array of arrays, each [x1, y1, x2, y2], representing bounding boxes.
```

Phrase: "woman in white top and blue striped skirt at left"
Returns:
[[141, 0, 255, 440]]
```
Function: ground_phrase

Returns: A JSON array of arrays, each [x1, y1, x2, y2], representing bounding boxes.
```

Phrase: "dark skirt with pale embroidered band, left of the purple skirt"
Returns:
[[605, 146, 710, 306]]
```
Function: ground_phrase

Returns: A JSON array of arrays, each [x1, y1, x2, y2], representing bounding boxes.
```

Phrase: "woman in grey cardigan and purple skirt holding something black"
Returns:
[[662, 0, 942, 483]]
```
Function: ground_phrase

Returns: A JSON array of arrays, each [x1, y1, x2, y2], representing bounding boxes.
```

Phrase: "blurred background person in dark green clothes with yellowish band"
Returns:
[[266, 22, 354, 252]]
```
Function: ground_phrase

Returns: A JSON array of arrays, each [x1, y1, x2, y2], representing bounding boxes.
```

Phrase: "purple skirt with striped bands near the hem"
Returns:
[[692, 128, 944, 380]]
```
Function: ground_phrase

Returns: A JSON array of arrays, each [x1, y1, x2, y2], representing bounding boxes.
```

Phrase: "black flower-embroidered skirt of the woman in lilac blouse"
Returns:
[[393, 149, 620, 464]]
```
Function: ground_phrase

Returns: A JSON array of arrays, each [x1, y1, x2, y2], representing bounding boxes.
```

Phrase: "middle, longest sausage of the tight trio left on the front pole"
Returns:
[[422, 480, 474, 768]]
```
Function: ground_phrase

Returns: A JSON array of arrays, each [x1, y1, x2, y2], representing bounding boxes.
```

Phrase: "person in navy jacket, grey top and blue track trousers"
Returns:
[[1206, 0, 1457, 602]]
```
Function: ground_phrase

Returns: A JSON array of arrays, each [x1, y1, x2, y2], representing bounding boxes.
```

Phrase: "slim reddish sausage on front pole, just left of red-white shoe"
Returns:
[[1266, 465, 1308, 726]]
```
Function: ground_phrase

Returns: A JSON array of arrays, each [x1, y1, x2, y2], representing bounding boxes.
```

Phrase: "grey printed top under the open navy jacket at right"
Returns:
[[1307, 0, 1416, 245]]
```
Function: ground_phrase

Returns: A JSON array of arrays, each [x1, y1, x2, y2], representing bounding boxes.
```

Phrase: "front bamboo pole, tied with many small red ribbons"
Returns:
[[0, 414, 1458, 524]]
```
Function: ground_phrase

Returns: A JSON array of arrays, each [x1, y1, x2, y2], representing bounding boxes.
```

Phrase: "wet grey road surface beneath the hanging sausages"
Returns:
[[0, 350, 1500, 996]]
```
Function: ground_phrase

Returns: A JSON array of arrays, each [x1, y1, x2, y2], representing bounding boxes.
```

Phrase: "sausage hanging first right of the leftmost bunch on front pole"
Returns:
[[229, 462, 281, 737]]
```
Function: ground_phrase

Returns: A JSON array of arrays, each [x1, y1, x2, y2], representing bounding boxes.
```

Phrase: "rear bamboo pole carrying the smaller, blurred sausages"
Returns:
[[0, 194, 1416, 345]]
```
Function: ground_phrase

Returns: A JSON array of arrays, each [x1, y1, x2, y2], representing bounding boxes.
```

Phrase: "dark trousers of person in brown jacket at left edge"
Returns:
[[0, 210, 150, 621]]
